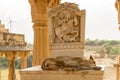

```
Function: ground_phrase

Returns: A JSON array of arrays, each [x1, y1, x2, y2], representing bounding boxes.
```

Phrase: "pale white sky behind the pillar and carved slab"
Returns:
[[0, 0, 120, 43]]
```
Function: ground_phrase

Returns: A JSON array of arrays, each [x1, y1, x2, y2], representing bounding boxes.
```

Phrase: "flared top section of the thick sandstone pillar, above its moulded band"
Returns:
[[29, 0, 47, 24]]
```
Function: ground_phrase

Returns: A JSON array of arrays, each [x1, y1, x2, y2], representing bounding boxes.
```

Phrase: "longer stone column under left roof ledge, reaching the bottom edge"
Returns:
[[5, 51, 16, 80]]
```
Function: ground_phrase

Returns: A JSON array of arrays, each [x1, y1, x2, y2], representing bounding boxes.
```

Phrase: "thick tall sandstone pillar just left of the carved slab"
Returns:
[[29, 0, 60, 66]]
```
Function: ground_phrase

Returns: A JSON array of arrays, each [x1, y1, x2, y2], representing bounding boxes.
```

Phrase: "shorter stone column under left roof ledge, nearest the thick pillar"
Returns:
[[19, 51, 29, 69]]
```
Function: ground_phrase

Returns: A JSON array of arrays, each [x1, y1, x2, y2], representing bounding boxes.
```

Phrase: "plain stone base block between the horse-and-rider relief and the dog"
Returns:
[[50, 43, 84, 57]]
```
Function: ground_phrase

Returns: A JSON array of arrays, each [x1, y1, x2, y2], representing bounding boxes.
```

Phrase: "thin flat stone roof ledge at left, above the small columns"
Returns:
[[0, 46, 32, 51]]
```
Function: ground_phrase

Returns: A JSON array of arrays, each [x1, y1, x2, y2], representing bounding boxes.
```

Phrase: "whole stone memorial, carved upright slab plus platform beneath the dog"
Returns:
[[20, 0, 104, 80]]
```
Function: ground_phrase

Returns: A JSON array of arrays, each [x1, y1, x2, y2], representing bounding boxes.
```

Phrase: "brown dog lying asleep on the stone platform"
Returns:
[[41, 55, 101, 71]]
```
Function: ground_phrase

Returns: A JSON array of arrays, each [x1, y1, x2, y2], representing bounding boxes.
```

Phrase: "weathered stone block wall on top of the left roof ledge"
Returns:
[[0, 22, 26, 46]]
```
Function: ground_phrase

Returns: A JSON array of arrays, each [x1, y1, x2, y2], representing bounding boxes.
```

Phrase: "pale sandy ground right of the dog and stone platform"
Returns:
[[85, 53, 117, 80]]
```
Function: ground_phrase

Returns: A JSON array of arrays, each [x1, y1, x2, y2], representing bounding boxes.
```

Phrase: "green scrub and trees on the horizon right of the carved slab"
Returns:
[[85, 39, 120, 55]]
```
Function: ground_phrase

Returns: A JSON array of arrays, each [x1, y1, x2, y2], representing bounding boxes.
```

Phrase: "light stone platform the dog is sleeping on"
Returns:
[[20, 66, 104, 80]]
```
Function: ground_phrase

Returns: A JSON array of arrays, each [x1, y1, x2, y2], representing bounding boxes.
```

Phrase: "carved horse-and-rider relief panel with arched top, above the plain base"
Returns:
[[48, 3, 83, 44]]
